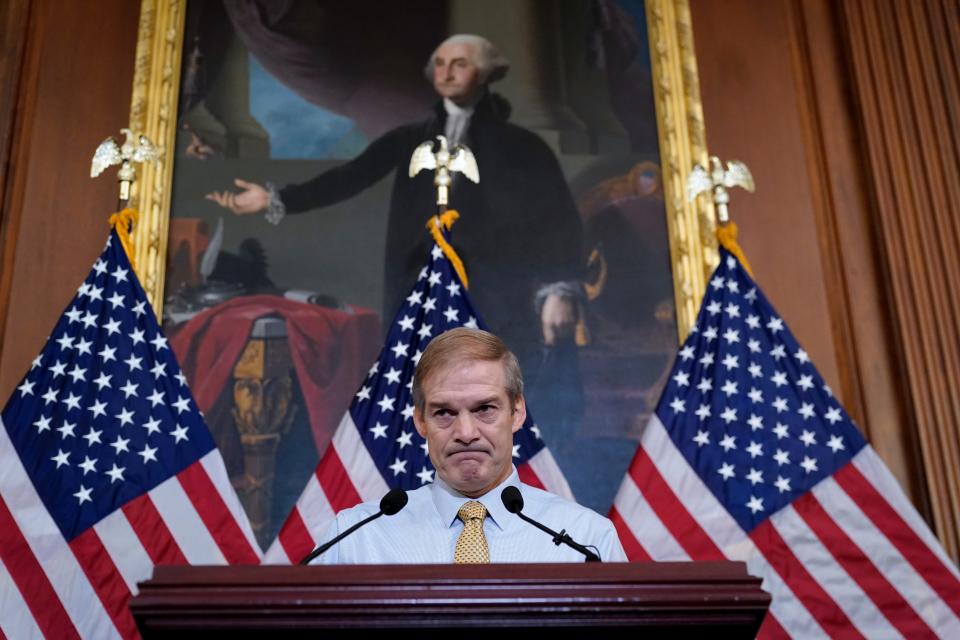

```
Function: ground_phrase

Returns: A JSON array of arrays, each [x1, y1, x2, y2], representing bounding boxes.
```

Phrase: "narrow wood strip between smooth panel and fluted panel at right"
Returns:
[[791, 0, 930, 515]]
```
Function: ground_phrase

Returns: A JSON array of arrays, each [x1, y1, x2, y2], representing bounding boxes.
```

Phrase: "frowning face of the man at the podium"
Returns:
[[413, 360, 527, 498]]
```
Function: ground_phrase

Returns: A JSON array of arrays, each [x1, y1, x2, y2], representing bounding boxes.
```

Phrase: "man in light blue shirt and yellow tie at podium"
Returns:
[[314, 328, 626, 564]]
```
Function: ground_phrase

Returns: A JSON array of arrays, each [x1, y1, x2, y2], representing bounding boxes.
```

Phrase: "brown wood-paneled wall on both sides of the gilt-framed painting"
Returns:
[[0, 0, 960, 559]]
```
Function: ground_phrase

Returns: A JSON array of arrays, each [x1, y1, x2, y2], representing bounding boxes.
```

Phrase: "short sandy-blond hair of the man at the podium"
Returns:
[[412, 327, 523, 413]]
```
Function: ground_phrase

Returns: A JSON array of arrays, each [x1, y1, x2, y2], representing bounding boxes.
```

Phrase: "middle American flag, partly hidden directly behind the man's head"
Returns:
[[265, 221, 572, 564]]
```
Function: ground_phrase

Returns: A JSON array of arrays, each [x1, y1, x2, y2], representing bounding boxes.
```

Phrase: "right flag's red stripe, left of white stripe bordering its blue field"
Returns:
[[629, 447, 726, 560]]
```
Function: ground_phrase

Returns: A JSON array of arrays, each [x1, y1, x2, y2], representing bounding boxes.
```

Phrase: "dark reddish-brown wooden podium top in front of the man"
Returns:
[[130, 562, 770, 638]]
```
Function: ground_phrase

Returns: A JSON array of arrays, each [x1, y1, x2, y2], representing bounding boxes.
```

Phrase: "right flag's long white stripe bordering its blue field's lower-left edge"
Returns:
[[636, 414, 826, 638]]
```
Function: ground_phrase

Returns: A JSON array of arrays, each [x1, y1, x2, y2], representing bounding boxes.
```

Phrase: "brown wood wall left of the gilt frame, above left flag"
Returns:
[[0, 0, 139, 399]]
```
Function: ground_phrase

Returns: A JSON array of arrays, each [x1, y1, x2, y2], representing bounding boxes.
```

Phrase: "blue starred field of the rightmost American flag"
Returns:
[[663, 248, 872, 524]]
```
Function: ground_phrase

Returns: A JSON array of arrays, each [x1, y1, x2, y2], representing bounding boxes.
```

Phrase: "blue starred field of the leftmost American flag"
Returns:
[[3, 230, 231, 536]]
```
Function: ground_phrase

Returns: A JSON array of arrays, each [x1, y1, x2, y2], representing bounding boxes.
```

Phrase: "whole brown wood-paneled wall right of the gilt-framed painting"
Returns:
[[691, 0, 960, 560]]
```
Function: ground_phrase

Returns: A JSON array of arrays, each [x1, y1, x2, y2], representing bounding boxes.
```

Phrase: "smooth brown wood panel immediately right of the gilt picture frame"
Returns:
[[691, 0, 843, 390]]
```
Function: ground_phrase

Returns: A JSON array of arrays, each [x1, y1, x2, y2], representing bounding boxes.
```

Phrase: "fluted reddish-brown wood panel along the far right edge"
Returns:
[[842, 0, 960, 560]]
